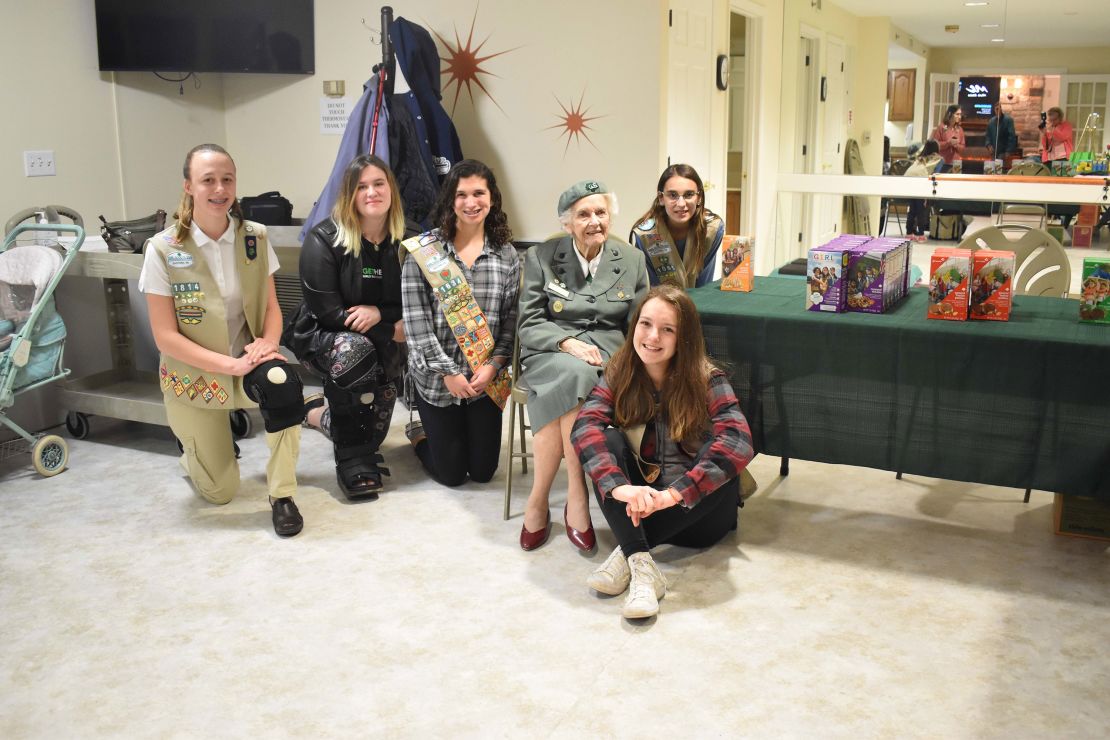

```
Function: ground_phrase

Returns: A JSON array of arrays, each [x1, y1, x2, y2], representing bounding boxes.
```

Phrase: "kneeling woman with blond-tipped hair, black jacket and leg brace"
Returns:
[[289, 154, 405, 500]]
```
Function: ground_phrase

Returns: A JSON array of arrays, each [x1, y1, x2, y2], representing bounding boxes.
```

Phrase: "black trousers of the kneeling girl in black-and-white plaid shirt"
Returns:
[[415, 391, 501, 486]]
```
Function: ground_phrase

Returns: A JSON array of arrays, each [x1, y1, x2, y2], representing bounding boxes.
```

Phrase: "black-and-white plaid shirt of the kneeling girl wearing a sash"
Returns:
[[401, 231, 521, 406]]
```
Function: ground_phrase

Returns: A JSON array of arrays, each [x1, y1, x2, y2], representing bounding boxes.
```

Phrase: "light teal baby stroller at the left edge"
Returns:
[[0, 224, 84, 476]]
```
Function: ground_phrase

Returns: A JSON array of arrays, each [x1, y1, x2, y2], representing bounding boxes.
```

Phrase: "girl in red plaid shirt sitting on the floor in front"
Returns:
[[571, 285, 755, 619]]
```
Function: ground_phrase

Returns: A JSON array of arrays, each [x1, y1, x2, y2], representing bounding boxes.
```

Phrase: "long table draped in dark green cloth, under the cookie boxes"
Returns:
[[690, 277, 1110, 500]]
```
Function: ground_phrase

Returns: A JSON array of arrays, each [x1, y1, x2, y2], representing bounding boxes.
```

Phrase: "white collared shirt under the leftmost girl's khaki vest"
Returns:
[[139, 219, 278, 357]]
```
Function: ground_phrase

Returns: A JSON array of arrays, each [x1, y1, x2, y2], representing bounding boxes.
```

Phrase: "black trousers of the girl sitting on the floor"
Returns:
[[594, 428, 740, 557]]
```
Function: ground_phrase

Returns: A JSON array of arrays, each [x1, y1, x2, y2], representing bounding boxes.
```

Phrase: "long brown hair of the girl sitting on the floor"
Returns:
[[605, 284, 715, 444]]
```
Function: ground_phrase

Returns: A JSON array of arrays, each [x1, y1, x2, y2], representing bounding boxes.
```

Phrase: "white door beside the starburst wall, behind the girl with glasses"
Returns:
[[667, 0, 710, 184]]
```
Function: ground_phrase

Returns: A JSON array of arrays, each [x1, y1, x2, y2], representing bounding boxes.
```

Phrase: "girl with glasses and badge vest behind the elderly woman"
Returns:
[[628, 164, 725, 288]]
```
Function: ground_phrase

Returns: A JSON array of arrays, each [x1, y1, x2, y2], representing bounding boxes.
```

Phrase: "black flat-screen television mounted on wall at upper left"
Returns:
[[95, 0, 316, 74]]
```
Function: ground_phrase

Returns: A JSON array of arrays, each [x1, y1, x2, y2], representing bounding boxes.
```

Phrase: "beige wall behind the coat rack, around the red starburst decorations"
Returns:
[[224, 0, 663, 240]]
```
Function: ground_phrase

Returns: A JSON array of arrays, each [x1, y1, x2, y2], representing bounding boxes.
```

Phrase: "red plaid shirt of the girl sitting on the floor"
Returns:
[[571, 371, 755, 506]]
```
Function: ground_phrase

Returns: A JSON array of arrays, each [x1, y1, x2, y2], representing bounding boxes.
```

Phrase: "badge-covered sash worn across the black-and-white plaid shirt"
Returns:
[[402, 233, 513, 409]]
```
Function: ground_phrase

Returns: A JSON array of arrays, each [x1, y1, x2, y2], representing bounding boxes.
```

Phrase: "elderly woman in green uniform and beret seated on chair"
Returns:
[[518, 180, 648, 553]]
